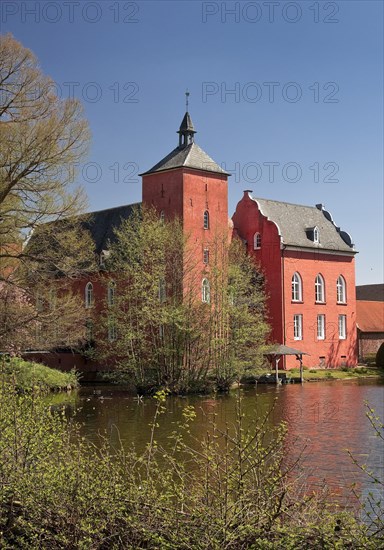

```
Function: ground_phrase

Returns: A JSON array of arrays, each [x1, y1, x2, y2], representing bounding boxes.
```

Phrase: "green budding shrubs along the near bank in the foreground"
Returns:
[[0, 383, 384, 550]]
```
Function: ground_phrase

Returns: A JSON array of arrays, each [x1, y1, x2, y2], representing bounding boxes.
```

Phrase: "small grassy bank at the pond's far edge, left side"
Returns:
[[0, 357, 78, 393]]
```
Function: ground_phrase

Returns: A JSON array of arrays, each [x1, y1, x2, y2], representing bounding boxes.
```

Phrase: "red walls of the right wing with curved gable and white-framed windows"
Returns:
[[233, 191, 357, 368]]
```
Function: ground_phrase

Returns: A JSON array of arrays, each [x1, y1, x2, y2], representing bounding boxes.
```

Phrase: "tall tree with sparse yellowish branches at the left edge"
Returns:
[[0, 34, 93, 351]]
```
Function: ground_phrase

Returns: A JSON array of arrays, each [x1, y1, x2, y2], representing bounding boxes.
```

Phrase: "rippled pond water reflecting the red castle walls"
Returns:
[[63, 380, 384, 502]]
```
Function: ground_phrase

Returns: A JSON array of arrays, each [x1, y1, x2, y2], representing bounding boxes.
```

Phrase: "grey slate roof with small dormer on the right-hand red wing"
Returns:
[[253, 198, 356, 253]]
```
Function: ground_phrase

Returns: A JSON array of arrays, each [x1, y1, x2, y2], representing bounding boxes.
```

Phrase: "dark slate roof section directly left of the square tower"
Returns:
[[82, 203, 141, 254]]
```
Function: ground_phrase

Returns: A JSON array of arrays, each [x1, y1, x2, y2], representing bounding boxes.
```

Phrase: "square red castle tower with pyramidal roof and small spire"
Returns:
[[141, 110, 229, 286]]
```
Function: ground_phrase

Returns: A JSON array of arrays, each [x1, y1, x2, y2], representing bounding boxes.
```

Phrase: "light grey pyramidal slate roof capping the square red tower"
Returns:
[[140, 143, 231, 176]]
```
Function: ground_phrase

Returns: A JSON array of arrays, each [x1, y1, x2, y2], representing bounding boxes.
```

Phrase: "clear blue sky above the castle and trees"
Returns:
[[0, 0, 384, 284]]
